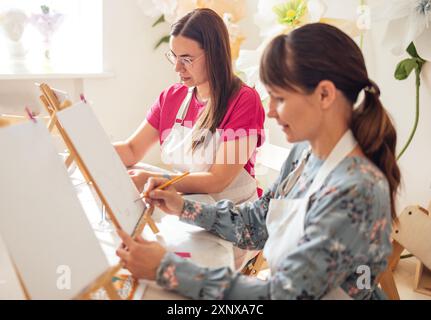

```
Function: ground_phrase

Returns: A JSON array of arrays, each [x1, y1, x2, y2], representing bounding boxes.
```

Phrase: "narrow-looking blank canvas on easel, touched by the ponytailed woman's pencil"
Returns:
[[57, 103, 145, 234]]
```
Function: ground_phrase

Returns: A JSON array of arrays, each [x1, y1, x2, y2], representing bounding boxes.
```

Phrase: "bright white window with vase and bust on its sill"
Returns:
[[0, 0, 103, 74]]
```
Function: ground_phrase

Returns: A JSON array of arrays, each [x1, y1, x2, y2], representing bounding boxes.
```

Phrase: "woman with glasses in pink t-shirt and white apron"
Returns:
[[115, 9, 265, 203]]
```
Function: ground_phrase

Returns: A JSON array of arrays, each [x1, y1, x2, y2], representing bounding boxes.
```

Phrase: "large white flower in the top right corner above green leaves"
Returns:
[[372, 0, 431, 61]]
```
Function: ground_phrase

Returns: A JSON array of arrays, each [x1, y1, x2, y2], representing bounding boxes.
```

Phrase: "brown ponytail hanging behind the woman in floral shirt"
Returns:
[[351, 80, 401, 221]]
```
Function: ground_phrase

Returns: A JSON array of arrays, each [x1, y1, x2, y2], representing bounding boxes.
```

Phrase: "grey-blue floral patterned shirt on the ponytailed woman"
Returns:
[[157, 143, 392, 299]]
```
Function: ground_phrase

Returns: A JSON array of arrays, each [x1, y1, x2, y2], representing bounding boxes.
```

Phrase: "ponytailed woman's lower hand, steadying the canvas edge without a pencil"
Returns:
[[116, 230, 166, 280]]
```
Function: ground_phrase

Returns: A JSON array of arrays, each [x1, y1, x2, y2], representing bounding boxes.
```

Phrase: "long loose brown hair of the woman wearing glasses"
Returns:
[[170, 8, 242, 150]]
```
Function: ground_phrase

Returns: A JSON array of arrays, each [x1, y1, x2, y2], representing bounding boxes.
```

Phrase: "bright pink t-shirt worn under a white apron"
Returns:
[[147, 84, 265, 176]]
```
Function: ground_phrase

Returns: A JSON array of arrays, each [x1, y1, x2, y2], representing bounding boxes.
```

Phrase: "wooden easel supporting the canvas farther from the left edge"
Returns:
[[40, 83, 159, 237]]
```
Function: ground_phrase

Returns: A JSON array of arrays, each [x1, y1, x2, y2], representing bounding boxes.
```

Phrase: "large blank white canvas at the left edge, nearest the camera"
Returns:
[[0, 122, 109, 299]]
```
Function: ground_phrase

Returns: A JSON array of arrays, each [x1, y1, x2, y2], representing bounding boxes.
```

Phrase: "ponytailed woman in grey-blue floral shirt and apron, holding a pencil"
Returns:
[[117, 23, 400, 299]]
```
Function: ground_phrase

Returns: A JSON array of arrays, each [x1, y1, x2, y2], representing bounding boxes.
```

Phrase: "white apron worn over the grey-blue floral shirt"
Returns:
[[263, 130, 357, 300]]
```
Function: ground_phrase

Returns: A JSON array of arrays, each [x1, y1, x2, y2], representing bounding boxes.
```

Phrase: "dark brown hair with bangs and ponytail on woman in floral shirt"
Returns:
[[260, 23, 401, 220]]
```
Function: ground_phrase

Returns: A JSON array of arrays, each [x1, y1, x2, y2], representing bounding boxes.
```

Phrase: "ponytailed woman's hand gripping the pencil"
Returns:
[[144, 177, 184, 216]]
